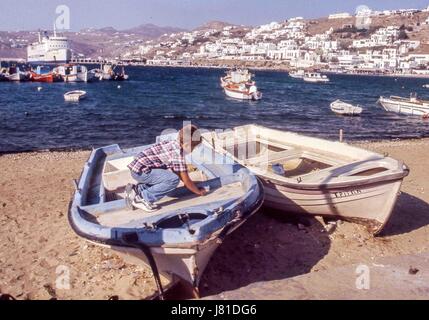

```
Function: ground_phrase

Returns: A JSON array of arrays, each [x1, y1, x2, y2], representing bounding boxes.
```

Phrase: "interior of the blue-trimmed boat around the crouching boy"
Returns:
[[81, 146, 249, 229]]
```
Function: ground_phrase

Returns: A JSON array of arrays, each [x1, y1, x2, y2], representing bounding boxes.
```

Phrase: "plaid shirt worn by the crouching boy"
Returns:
[[128, 140, 188, 174]]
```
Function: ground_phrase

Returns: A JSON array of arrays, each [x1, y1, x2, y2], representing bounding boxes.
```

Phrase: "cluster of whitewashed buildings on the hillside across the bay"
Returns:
[[130, 8, 429, 75]]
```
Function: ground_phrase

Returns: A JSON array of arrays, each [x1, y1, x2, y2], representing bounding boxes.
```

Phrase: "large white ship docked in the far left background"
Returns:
[[27, 29, 71, 64]]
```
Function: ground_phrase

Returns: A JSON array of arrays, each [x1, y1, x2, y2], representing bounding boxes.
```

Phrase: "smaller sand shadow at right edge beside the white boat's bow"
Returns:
[[379, 193, 429, 237]]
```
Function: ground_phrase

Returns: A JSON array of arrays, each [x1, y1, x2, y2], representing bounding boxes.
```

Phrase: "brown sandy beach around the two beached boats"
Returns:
[[0, 139, 429, 299]]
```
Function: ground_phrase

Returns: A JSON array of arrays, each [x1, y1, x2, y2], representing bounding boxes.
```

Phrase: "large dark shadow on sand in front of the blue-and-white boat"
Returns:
[[200, 209, 330, 297]]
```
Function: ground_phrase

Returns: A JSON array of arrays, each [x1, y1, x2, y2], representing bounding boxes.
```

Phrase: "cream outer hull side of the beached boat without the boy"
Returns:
[[260, 177, 402, 234]]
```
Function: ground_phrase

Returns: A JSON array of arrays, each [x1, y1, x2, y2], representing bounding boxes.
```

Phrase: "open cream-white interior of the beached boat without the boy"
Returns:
[[206, 126, 393, 183]]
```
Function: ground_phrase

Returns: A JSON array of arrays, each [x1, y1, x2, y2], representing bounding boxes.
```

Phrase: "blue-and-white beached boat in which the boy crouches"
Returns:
[[69, 141, 263, 292]]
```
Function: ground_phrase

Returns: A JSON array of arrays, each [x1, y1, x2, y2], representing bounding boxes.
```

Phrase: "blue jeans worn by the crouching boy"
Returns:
[[131, 169, 180, 203]]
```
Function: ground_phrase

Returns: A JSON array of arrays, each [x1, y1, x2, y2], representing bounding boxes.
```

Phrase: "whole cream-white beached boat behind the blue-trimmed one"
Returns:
[[204, 125, 409, 234]]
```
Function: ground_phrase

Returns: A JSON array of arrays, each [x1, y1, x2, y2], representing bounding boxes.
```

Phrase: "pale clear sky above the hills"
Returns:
[[0, 0, 429, 31]]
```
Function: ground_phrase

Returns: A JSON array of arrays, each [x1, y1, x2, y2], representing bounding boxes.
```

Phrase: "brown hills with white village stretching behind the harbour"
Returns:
[[0, 7, 429, 74]]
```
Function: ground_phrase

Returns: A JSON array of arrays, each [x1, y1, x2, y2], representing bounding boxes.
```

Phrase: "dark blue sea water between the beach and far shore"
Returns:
[[0, 67, 429, 152]]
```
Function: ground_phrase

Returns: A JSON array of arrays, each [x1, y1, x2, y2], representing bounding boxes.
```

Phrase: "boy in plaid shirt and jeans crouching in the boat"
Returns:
[[126, 125, 206, 212]]
